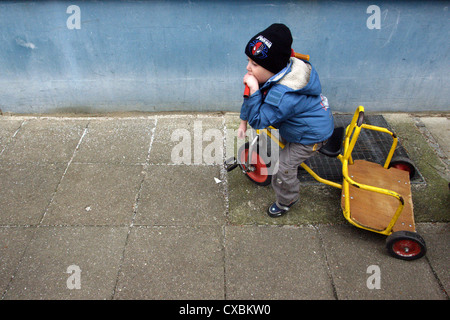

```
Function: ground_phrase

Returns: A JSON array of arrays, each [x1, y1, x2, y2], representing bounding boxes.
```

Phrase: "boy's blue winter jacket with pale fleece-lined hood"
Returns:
[[240, 58, 334, 145]]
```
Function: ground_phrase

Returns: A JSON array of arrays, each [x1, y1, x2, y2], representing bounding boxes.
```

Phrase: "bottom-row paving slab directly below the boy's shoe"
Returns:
[[225, 226, 334, 300]]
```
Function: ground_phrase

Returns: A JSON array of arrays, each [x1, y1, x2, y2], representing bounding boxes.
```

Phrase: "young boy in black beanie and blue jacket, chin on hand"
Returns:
[[238, 24, 334, 217]]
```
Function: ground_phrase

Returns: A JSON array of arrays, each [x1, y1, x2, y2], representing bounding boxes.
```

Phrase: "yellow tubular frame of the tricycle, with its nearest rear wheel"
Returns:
[[225, 106, 426, 260]]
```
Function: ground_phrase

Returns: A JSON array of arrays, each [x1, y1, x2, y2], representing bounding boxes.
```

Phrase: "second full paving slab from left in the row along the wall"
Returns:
[[74, 118, 155, 164]]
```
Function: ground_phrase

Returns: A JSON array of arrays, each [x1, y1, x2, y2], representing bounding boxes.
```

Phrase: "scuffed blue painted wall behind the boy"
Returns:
[[0, 0, 450, 113]]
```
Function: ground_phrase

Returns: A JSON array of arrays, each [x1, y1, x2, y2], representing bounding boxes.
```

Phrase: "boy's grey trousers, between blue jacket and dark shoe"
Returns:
[[272, 141, 326, 206]]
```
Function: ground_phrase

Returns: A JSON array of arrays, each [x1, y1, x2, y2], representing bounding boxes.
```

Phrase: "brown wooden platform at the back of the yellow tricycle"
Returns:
[[341, 160, 415, 231]]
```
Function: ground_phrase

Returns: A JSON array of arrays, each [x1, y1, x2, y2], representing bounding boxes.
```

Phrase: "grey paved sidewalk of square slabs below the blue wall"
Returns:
[[0, 113, 450, 300]]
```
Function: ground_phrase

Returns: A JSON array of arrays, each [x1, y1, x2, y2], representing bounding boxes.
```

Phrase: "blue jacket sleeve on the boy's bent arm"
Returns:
[[241, 89, 293, 129]]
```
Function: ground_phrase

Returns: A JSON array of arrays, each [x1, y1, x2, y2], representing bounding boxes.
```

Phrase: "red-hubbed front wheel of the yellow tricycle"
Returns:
[[238, 142, 272, 186]]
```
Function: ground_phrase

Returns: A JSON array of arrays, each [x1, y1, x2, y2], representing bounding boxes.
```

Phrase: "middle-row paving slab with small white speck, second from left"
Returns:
[[42, 163, 144, 226]]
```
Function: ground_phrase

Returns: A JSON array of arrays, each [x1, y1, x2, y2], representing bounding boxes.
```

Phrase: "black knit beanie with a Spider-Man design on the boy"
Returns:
[[245, 23, 292, 74]]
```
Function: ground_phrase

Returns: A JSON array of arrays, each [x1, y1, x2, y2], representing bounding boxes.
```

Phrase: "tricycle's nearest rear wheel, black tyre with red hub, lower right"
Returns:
[[386, 231, 427, 260]]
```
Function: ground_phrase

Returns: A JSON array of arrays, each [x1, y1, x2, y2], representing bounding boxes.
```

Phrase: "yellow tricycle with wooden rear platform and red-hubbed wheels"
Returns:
[[225, 56, 427, 260]]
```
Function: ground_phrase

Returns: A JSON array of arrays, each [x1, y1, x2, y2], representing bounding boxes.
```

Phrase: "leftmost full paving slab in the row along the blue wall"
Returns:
[[0, 118, 88, 163]]
